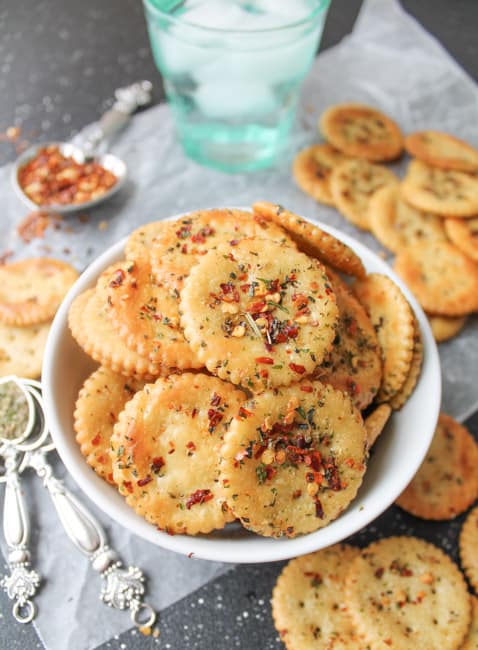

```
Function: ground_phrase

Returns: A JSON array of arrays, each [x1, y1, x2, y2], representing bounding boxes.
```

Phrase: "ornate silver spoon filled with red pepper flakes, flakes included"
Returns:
[[11, 81, 152, 214]]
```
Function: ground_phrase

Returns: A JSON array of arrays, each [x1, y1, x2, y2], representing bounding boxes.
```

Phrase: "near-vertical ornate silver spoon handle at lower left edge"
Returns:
[[0, 447, 40, 623]]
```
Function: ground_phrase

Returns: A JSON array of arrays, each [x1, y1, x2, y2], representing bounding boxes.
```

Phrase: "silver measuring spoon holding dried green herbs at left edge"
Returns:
[[0, 376, 48, 623]]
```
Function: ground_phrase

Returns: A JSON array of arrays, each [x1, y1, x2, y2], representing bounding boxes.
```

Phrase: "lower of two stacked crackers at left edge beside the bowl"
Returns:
[[0, 323, 50, 379]]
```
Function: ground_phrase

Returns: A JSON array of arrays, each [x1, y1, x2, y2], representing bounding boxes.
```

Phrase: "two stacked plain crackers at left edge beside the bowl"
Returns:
[[0, 257, 78, 379]]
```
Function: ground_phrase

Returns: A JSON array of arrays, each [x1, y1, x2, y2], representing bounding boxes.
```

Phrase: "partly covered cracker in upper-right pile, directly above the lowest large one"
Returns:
[[369, 185, 446, 253]]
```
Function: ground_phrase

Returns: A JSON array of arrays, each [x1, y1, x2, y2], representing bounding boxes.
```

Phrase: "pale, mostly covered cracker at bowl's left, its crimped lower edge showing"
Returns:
[[68, 289, 164, 380]]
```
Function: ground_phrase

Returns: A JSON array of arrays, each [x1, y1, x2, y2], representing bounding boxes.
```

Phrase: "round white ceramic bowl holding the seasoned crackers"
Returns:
[[42, 213, 441, 563]]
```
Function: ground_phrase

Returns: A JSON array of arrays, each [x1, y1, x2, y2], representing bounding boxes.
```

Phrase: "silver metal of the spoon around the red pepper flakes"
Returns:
[[11, 81, 153, 214]]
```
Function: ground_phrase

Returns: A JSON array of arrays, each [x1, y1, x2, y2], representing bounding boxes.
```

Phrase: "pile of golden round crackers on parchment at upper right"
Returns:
[[293, 104, 478, 342]]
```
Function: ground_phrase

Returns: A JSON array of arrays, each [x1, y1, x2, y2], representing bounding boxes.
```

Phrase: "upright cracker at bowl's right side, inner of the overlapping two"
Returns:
[[352, 273, 415, 402]]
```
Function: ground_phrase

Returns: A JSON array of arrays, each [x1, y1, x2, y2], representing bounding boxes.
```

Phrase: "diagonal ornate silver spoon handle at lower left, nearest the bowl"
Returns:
[[27, 448, 156, 627]]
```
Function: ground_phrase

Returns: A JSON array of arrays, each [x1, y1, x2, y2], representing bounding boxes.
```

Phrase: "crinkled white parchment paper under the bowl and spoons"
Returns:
[[0, 0, 478, 650]]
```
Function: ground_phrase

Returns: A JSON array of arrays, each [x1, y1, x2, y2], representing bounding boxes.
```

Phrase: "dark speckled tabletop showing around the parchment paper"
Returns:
[[0, 0, 478, 650]]
